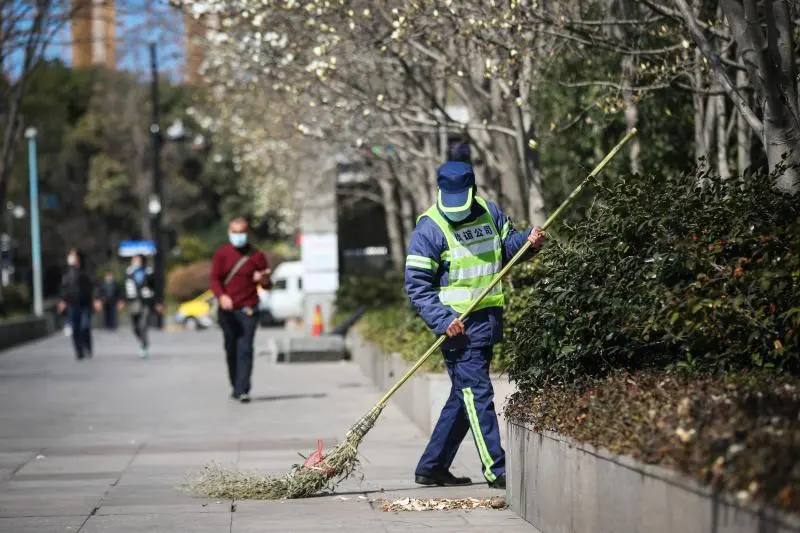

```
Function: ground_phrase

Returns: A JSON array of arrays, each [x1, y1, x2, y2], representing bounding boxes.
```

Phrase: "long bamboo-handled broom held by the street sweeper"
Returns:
[[188, 128, 637, 499]]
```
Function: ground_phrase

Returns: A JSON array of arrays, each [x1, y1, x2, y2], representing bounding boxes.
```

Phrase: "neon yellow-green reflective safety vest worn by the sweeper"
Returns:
[[418, 197, 505, 313]]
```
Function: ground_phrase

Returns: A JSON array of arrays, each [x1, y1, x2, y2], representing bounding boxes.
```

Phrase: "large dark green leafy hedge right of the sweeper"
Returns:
[[507, 171, 800, 388]]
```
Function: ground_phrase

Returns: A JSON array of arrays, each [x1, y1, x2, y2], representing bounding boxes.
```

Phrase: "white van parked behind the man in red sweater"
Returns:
[[259, 261, 303, 325]]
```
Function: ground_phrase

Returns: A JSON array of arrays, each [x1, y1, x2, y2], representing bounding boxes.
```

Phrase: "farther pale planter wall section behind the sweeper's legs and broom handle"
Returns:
[[347, 330, 516, 438]]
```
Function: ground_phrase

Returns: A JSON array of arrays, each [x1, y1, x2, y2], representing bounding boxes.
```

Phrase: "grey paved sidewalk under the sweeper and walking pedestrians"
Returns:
[[0, 330, 535, 533]]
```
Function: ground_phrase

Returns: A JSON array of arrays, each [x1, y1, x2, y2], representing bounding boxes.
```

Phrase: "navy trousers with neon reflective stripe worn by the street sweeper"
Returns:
[[416, 346, 506, 481]]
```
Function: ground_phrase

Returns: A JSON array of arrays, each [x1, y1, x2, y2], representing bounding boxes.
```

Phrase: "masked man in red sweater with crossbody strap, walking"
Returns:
[[211, 217, 270, 403]]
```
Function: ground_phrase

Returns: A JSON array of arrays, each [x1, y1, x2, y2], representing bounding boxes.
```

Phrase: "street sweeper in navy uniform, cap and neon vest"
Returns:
[[405, 140, 545, 489]]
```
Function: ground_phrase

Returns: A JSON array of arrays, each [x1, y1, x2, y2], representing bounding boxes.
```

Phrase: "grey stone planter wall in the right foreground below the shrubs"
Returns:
[[506, 421, 800, 533]]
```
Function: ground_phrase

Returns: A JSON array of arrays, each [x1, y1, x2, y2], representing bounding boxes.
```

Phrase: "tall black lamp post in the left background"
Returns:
[[148, 42, 165, 328]]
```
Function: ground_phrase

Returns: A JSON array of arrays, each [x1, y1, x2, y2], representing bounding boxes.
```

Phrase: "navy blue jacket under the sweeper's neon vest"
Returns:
[[405, 195, 533, 350]]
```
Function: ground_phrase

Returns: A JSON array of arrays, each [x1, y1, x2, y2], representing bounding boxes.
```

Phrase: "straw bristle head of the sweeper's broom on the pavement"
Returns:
[[185, 406, 383, 500]]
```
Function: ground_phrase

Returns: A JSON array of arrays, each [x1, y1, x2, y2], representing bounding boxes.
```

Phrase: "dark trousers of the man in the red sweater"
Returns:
[[219, 309, 258, 396]]
